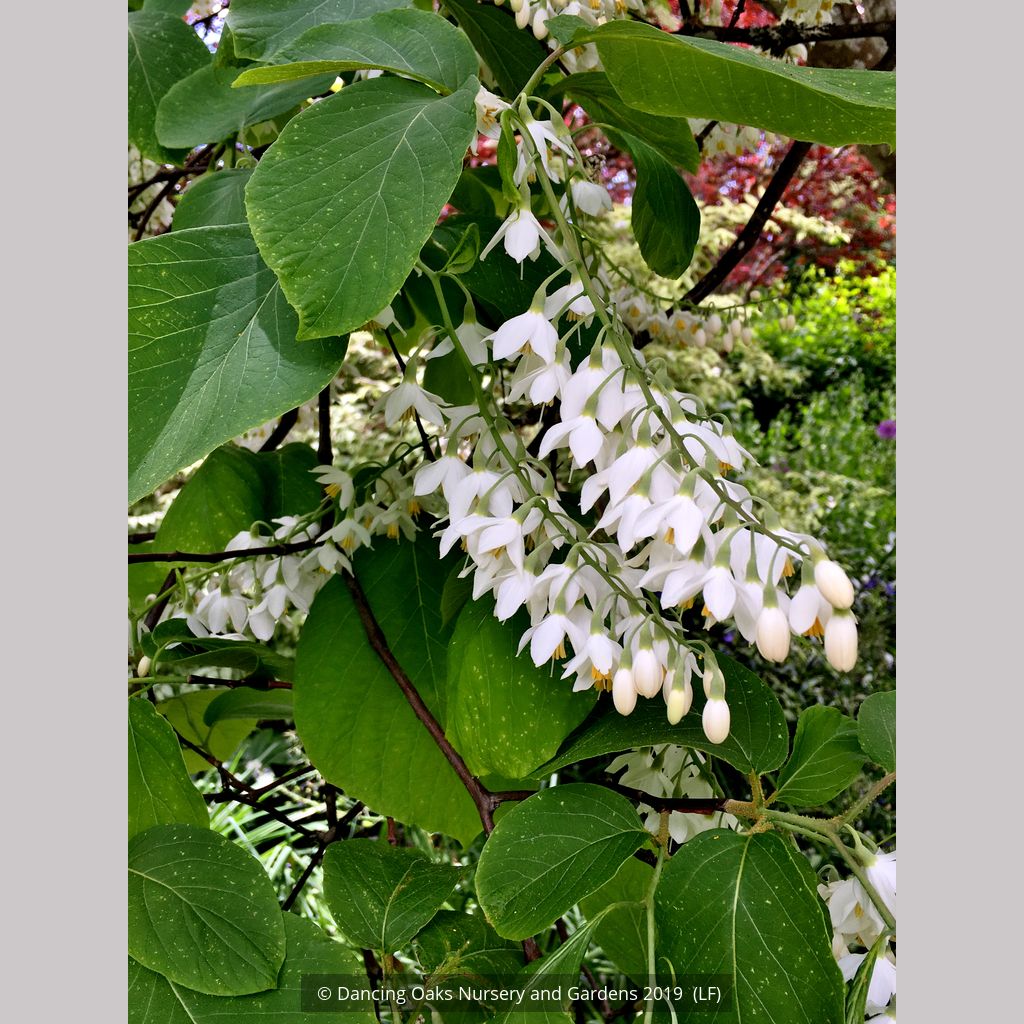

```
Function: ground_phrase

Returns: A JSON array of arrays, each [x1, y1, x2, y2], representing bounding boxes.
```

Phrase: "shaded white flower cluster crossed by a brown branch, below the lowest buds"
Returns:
[[607, 743, 738, 844]]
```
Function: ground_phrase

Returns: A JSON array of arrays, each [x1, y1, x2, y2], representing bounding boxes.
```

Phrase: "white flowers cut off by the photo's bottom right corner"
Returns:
[[818, 850, 896, 1024]]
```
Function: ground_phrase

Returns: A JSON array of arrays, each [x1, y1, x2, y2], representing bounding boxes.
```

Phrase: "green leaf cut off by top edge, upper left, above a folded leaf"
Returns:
[[227, 0, 409, 60]]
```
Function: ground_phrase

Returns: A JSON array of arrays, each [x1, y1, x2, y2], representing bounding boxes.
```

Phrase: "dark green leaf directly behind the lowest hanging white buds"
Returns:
[[534, 654, 790, 778]]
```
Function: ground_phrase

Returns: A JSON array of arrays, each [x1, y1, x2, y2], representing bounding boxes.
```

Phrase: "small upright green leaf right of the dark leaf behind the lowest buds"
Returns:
[[772, 705, 864, 807]]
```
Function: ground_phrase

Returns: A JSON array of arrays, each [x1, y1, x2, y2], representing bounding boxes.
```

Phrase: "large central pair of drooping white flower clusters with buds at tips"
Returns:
[[399, 100, 856, 742]]
